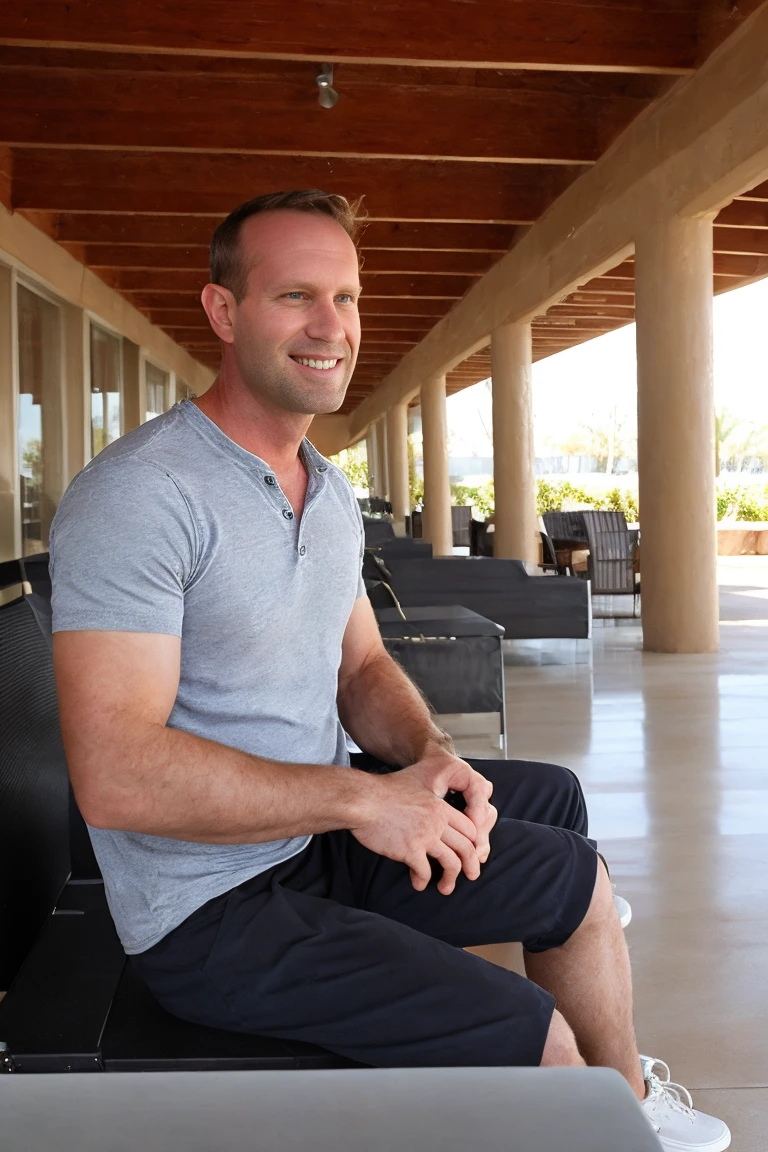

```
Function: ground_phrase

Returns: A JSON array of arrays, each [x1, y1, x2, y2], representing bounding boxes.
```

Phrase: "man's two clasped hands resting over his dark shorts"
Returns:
[[350, 750, 496, 896]]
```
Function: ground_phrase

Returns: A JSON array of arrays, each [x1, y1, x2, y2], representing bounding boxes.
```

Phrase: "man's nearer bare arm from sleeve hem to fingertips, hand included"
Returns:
[[53, 631, 478, 893]]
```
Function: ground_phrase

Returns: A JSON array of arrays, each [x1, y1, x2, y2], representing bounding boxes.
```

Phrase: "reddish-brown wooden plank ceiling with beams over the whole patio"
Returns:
[[0, 0, 768, 411]]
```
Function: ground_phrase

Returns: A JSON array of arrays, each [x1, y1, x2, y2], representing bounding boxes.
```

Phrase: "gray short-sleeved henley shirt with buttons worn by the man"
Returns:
[[51, 401, 365, 954]]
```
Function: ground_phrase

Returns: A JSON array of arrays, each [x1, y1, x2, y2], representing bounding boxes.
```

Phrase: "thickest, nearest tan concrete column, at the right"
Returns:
[[634, 218, 718, 652]]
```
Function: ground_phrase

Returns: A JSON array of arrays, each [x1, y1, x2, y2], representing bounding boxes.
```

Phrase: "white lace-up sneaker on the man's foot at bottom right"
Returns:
[[640, 1056, 731, 1152]]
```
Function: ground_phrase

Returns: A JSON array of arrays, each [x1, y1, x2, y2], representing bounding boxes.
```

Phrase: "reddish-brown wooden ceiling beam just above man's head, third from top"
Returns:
[[13, 149, 584, 225]]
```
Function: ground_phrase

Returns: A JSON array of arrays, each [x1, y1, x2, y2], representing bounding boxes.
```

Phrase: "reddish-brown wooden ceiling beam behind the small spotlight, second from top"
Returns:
[[0, 58, 648, 164]]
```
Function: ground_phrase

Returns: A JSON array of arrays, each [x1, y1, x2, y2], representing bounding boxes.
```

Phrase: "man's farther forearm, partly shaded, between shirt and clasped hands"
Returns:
[[339, 652, 454, 767]]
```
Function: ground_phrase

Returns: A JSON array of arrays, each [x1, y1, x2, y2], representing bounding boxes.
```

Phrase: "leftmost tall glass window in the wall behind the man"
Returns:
[[16, 285, 61, 556]]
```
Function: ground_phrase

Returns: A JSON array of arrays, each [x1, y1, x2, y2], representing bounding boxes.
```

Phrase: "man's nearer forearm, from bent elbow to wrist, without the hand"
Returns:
[[68, 727, 373, 843]]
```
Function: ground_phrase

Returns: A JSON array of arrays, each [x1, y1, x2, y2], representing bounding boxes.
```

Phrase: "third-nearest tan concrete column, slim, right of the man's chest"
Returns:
[[421, 376, 454, 556]]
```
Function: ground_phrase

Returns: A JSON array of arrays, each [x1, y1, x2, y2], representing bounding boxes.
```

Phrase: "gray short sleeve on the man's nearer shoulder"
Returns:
[[51, 456, 199, 636]]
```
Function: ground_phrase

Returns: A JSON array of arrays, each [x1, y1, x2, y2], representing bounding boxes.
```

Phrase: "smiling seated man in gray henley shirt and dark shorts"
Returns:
[[52, 191, 730, 1152]]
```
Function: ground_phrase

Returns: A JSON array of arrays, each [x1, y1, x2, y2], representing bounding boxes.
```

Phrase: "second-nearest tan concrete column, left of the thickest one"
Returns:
[[491, 321, 539, 563]]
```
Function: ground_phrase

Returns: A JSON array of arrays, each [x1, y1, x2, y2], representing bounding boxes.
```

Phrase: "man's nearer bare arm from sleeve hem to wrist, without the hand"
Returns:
[[53, 631, 367, 843]]
